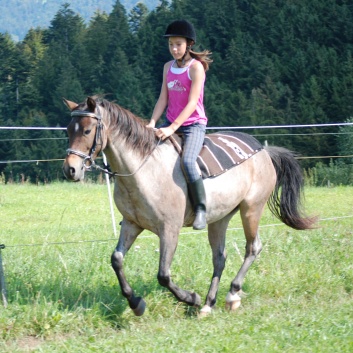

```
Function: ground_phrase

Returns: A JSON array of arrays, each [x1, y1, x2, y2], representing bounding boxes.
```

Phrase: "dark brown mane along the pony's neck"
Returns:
[[96, 99, 156, 157]]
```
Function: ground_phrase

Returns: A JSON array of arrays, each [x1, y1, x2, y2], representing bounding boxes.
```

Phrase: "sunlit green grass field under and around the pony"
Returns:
[[0, 183, 353, 353]]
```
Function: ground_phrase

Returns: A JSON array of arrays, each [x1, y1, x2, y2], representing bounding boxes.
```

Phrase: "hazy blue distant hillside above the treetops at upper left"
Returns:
[[0, 0, 158, 41]]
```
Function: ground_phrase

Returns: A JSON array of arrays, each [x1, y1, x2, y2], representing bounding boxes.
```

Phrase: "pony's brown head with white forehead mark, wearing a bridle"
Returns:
[[63, 97, 107, 181]]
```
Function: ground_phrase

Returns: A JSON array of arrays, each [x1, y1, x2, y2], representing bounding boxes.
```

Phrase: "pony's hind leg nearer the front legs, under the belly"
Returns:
[[200, 216, 231, 316]]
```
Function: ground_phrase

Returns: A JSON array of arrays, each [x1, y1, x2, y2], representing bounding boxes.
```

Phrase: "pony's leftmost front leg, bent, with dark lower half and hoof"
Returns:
[[111, 219, 146, 316]]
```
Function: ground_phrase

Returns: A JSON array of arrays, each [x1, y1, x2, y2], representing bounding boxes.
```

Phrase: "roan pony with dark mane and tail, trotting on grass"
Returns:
[[63, 97, 316, 316]]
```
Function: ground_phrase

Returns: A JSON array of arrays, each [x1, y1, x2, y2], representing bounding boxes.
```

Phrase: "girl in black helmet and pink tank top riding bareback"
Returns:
[[147, 20, 212, 229]]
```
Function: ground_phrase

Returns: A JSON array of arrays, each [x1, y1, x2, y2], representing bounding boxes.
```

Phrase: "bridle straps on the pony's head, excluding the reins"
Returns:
[[66, 107, 103, 171]]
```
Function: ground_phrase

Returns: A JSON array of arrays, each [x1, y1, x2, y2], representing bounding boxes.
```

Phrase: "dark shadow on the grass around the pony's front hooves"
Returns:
[[4, 270, 198, 330]]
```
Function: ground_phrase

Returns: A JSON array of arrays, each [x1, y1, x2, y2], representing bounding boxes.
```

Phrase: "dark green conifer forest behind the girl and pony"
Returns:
[[0, 0, 353, 182]]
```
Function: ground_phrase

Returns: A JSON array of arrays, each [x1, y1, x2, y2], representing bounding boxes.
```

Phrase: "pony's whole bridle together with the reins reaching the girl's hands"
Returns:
[[66, 106, 161, 177]]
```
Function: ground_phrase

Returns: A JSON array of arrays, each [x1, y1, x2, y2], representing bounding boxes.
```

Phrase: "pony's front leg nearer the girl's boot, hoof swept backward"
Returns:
[[157, 230, 201, 307]]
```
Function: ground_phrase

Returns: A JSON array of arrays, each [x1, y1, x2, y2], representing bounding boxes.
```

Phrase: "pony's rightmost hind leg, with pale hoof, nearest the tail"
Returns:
[[226, 203, 264, 310]]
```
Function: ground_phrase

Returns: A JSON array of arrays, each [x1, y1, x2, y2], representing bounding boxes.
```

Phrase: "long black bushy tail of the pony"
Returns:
[[265, 146, 317, 230]]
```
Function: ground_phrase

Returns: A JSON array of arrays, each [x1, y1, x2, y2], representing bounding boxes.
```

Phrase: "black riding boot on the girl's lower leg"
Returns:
[[188, 178, 206, 230]]
